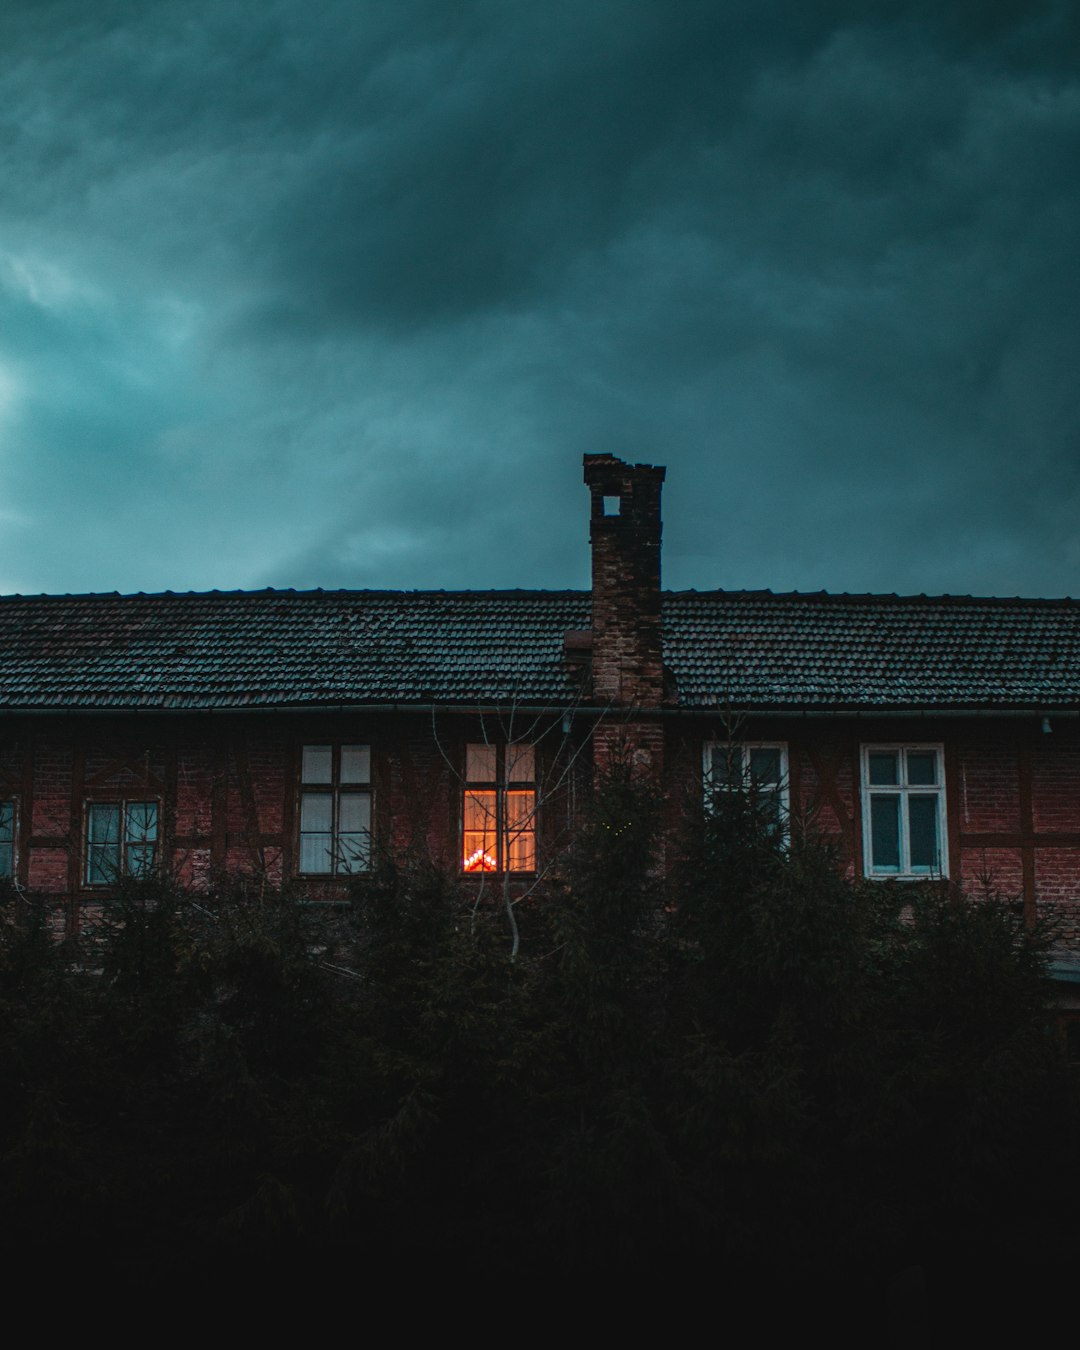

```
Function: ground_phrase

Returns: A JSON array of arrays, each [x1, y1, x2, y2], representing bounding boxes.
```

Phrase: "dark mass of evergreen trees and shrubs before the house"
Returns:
[[0, 775, 1080, 1317]]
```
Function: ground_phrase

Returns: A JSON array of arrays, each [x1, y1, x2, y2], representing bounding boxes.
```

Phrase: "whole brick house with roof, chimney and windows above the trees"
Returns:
[[0, 455, 1080, 980]]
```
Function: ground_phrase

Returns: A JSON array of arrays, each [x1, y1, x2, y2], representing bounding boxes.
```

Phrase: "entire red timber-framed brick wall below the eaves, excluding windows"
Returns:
[[0, 709, 1080, 949]]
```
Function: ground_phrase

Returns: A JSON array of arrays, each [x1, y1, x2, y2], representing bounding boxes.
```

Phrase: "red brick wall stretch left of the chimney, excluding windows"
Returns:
[[0, 714, 590, 914]]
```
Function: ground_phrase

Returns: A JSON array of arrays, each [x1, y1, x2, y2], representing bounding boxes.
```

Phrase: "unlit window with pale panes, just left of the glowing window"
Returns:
[[300, 745, 371, 876]]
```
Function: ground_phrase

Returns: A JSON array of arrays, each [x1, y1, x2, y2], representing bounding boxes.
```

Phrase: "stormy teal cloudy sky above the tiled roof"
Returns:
[[0, 0, 1080, 595]]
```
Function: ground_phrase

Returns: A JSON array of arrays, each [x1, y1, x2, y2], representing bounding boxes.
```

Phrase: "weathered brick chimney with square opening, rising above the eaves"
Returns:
[[585, 455, 664, 709]]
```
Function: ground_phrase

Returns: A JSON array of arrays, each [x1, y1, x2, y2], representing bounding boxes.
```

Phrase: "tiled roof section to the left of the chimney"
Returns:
[[0, 591, 589, 709]]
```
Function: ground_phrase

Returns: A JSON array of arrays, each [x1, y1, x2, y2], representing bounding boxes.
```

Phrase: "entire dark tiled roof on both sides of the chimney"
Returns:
[[0, 590, 1080, 711]]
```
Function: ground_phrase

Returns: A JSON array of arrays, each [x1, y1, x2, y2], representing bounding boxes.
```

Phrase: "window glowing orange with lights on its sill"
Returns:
[[462, 744, 536, 872]]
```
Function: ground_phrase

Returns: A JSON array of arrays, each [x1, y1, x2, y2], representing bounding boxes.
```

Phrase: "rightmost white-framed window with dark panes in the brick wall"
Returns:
[[863, 745, 948, 878]]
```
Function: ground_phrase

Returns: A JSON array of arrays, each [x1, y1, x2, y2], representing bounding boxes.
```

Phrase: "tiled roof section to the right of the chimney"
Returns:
[[664, 591, 1080, 709]]
